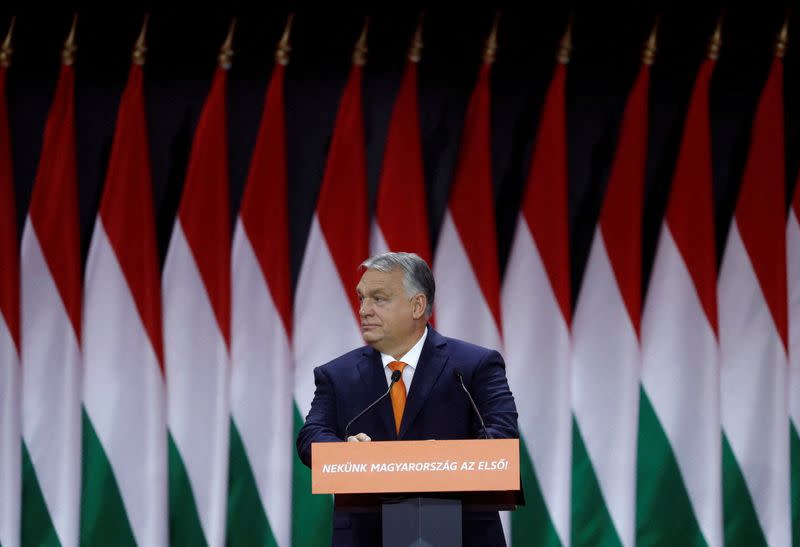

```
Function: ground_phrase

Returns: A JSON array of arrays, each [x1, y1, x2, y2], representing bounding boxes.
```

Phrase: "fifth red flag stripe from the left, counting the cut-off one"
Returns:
[[239, 64, 292, 337]]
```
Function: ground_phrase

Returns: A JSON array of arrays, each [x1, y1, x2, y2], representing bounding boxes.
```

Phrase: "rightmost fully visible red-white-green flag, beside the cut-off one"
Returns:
[[718, 52, 791, 545]]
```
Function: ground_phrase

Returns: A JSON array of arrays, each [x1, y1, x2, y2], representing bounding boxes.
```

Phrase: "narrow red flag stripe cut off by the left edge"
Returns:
[[0, 66, 19, 348]]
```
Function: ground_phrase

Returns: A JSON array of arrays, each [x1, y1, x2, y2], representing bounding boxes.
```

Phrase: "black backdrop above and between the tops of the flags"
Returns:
[[0, 6, 800, 312]]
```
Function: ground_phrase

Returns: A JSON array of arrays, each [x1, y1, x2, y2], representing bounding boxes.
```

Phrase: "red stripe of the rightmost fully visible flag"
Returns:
[[736, 57, 788, 348]]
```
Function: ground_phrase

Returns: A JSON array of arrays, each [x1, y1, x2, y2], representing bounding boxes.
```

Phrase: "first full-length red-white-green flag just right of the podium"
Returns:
[[502, 49, 572, 545]]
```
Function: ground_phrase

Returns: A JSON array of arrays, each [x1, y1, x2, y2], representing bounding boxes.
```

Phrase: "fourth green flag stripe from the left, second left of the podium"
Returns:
[[227, 419, 278, 547]]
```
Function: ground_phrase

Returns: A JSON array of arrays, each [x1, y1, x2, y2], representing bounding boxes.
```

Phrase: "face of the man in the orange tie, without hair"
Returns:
[[356, 270, 425, 357]]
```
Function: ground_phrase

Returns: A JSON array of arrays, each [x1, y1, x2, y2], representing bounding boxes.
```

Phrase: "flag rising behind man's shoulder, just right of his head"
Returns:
[[433, 21, 509, 537]]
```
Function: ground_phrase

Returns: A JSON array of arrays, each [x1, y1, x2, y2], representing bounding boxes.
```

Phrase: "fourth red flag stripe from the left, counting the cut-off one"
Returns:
[[178, 68, 231, 346]]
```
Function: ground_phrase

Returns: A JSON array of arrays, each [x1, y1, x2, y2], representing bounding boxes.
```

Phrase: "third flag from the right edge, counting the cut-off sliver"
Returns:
[[637, 52, 722, 546]]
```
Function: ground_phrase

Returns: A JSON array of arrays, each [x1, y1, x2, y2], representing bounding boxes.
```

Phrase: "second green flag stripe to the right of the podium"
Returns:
[[572, 416, 622, 547]]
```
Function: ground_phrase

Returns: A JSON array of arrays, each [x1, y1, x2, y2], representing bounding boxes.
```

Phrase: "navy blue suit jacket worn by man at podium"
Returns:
[[297, 326, 519, 546]]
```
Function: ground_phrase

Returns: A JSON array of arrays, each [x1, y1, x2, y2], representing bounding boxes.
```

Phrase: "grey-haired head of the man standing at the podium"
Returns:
[[356, 253, 436, 358]]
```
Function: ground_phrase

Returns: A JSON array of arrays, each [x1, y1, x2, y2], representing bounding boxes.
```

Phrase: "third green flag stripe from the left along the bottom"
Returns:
[[167, 434, 208, 546]]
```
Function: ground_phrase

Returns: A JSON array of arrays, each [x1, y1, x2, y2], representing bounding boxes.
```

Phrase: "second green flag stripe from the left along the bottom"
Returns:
[[80, 408, 136, 546]]
